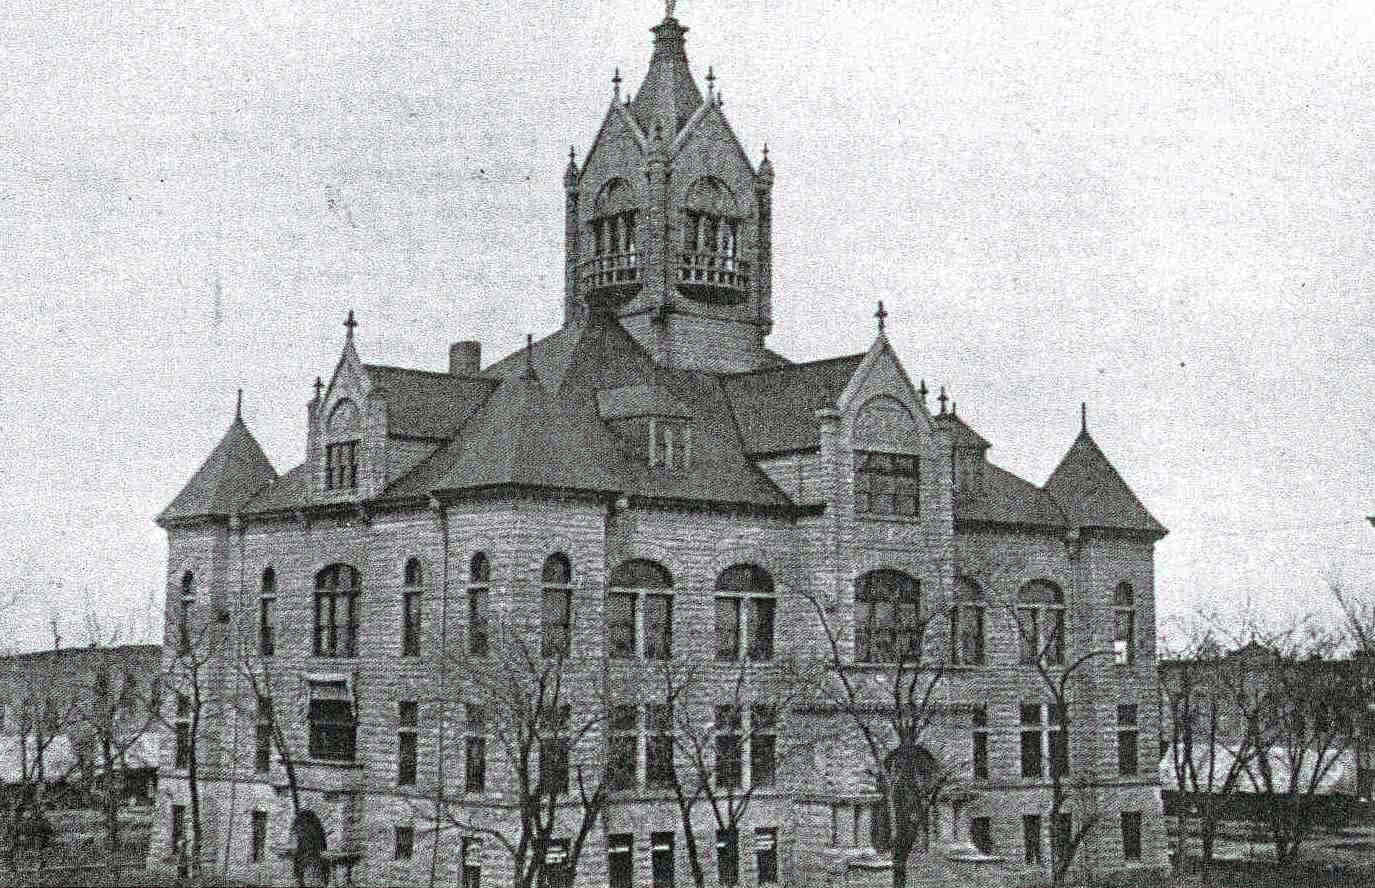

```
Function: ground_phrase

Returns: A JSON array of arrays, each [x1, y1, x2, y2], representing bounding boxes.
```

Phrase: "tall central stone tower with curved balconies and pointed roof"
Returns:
[[564, 15, 773, 373]]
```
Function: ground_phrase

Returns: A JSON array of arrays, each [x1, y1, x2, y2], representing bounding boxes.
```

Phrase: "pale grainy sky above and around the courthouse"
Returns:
[[0, 0, 1375, 649]]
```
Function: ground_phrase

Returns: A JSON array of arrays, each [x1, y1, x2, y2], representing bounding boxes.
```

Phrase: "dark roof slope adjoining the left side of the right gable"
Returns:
[[721, 355, 865, 454]]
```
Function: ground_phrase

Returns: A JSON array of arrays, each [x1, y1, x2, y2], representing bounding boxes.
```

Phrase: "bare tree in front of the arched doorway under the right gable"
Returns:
[[793, 591, 958, 888]]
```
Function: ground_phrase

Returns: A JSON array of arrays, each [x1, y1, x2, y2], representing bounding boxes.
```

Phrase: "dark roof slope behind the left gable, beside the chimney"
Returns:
[[363, 364, 494, 439]]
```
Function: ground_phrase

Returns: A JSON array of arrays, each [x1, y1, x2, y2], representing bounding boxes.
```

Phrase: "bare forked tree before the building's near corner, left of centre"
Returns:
[[423, 619, 609, 888]]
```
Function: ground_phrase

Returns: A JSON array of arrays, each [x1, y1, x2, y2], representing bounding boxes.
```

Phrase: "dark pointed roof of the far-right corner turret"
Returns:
[[1045, 429, 1167, 536]]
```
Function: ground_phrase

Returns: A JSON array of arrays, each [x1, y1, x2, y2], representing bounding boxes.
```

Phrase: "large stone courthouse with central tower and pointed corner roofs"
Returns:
[[150, 8, 1165, 885]]
